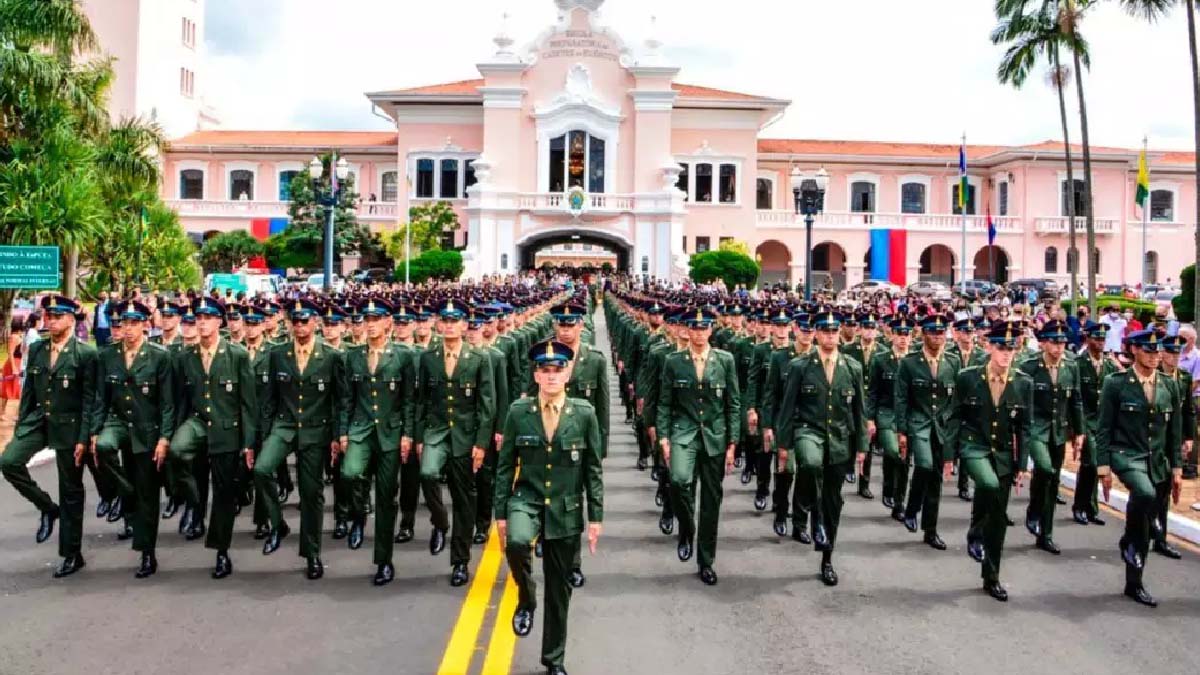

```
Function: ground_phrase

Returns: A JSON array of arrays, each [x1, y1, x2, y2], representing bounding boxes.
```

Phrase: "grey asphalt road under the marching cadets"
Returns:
[[0, 313, 1200, 675]]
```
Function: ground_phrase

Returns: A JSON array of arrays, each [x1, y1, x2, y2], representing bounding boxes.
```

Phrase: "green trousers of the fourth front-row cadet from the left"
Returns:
[[254, 434, 329, 557]]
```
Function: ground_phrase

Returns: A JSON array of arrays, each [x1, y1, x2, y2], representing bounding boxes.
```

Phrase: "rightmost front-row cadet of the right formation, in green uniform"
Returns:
[[1096, 329, 1183, 607]]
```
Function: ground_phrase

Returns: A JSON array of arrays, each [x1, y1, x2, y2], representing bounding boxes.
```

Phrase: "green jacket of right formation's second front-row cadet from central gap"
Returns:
[[774, 352, 868, 465]]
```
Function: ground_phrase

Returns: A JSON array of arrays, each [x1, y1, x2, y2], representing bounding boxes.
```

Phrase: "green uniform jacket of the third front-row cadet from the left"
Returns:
[[175, 338, 259, 455]]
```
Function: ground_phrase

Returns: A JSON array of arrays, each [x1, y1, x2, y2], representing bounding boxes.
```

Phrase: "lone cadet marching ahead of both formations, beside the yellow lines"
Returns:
[[496, 341, 604, 675]]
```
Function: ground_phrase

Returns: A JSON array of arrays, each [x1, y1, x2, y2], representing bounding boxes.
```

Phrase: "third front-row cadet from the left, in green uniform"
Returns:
[[169, 297, 259, 579]]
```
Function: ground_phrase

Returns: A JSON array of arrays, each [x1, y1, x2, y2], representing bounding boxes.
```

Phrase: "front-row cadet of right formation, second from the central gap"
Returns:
[[775, 311, 868, 586]]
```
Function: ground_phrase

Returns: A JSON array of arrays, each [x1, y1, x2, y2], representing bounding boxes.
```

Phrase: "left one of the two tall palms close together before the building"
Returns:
[[991, 0, 1094, 316]]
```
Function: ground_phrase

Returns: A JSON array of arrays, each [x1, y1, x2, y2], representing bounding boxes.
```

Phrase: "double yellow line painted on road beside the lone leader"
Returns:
[[438, 526, 517, 675]]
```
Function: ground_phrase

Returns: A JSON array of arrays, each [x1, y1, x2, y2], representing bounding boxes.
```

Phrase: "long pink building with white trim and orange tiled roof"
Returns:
[[163, 0, 1195, 287]]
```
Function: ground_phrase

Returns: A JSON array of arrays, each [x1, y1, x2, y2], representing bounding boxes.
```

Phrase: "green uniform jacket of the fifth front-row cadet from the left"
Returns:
[[346, 342, 415, 453]]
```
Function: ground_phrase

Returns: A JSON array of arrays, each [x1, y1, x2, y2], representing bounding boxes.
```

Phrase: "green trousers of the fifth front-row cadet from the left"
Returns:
[[342, 434, 400, 565]]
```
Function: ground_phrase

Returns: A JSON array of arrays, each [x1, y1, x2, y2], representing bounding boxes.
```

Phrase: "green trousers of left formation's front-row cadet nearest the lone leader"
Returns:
[[421, 443, 475, 565]]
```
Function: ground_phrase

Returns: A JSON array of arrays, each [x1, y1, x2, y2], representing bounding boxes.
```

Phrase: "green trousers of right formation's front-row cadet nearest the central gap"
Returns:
[[671, 447, 725, 567]]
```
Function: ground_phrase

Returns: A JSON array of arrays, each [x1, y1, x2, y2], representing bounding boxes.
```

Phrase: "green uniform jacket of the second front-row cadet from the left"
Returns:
[[92, 340, 175, 454]]
